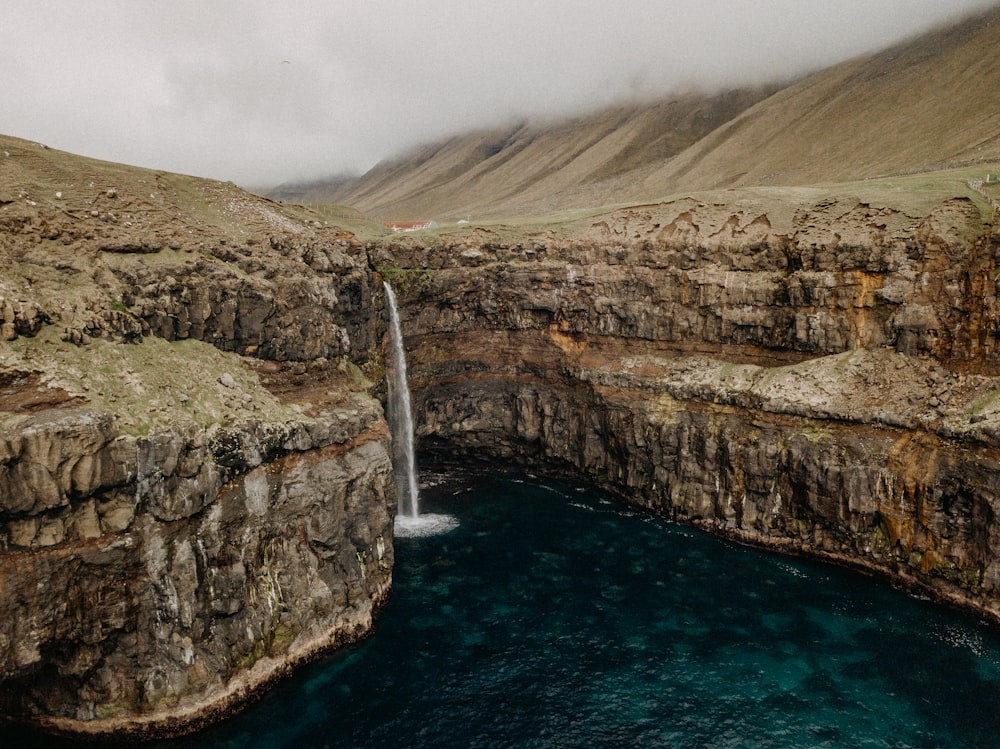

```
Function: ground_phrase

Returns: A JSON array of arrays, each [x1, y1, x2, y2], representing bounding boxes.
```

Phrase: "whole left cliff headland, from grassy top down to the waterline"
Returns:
[[0, 139, 395, 737]]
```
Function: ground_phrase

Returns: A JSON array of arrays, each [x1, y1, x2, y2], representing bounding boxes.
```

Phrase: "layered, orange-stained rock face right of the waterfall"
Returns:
[[382, 194, 1000, 618]]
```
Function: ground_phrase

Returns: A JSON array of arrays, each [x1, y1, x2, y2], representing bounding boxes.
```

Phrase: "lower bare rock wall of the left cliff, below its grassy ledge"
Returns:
[[0, 398, 394, 736]]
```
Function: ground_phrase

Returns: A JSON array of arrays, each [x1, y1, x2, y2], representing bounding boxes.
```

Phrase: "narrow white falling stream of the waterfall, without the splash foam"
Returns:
[[382, 281, 420, 518]]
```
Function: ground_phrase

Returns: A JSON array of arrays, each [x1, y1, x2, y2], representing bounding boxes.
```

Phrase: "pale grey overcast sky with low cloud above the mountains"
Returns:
[[0, 0, 997, 188]]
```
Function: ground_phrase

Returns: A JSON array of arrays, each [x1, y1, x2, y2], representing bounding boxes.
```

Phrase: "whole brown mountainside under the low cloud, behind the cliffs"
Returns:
[[272, 7, 1000, 220]]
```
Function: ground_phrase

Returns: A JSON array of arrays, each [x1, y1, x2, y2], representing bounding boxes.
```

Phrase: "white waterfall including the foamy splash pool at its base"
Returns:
[[382, 281, 458, 536]]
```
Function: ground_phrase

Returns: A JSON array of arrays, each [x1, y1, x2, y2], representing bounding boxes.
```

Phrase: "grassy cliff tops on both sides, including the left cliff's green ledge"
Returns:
[[0, 126, 1000, 434]]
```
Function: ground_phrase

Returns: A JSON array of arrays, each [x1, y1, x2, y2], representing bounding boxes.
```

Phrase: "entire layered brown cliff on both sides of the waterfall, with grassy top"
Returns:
[[0, 127, 1000, 737]]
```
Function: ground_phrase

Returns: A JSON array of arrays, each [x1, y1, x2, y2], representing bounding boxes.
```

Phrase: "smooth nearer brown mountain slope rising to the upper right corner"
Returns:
[[642, 5, 1000, 194]]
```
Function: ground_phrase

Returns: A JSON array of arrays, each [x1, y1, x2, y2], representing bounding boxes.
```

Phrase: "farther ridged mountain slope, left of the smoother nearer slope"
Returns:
[[271, 87, 774, 219]]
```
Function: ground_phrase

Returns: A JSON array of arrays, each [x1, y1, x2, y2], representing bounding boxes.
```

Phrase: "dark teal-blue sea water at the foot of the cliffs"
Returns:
[[5, 474, 1000, 749]]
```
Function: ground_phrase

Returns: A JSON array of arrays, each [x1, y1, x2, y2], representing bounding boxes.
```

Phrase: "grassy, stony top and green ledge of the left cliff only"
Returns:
[[0, 136, 373, 434]]
